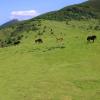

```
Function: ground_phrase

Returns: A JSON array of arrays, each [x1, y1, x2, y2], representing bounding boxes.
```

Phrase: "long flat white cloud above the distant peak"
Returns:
[[11, 10, 39, 19]]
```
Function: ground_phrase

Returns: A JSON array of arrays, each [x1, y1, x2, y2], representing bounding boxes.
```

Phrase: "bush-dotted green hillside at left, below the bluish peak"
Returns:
[[0, 19, 41, 47]]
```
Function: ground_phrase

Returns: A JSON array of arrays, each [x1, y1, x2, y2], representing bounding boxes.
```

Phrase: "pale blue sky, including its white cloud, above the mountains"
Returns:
[[0, 0, 86, 25]]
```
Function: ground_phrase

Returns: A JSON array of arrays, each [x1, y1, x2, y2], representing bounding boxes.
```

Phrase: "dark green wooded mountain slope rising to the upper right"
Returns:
[[36, 0, 100, 20]]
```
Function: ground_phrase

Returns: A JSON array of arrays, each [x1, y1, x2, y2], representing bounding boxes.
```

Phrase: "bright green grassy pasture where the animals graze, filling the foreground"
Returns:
[[0, 21, 100, 100]]
